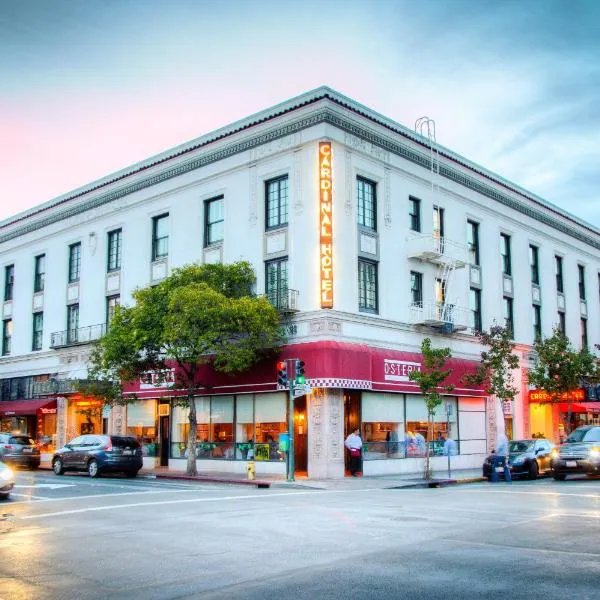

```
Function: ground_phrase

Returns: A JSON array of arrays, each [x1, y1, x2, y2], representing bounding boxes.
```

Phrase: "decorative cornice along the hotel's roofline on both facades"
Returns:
[[0, 95, 600, 249]]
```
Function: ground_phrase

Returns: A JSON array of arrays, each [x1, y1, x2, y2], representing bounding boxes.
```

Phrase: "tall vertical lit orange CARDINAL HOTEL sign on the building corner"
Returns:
[[319, 142, 333, 308]]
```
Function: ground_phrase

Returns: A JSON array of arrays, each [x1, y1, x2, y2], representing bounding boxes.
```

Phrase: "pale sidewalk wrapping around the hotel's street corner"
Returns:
[[139, 469, 485, 490]]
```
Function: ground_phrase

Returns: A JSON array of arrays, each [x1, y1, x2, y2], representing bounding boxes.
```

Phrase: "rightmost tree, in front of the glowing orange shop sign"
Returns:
[[528, 327, 600, 433]]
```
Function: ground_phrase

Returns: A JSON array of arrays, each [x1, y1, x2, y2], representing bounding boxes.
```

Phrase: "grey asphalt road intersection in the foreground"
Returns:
[[0, 472, 600, 600]]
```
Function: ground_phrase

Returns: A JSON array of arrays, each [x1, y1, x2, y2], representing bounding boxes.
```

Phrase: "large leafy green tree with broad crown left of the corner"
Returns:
[[81, 262, 284, 475]]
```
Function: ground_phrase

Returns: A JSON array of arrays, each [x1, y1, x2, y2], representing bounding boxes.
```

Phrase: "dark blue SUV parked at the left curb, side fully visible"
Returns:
[[52, 434, 142, 477]]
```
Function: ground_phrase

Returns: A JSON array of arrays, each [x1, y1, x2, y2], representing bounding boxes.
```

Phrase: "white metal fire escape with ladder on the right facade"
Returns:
[[407, 117, 468, 333]]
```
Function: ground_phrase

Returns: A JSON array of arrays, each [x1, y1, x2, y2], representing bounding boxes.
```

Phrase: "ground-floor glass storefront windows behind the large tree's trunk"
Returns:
[[171, 393, 287, 461]]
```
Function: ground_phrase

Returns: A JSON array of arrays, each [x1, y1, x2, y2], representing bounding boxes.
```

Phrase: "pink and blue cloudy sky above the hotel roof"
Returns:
[[0, 0, 600, 227]]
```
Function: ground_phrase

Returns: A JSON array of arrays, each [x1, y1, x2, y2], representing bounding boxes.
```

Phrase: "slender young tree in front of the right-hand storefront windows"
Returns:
[[408, 338, 454, 479]]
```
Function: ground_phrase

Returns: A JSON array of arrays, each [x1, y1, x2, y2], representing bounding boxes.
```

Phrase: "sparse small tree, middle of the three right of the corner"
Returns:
[[463, 325, 519, 430]]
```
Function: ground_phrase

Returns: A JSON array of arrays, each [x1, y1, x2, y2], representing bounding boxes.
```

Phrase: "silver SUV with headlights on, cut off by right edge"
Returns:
[[552, 425, 600, 481]]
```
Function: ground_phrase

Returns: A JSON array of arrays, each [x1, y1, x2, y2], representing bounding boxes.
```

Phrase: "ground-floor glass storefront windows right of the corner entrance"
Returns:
[[361, 392, 459, 460]]
